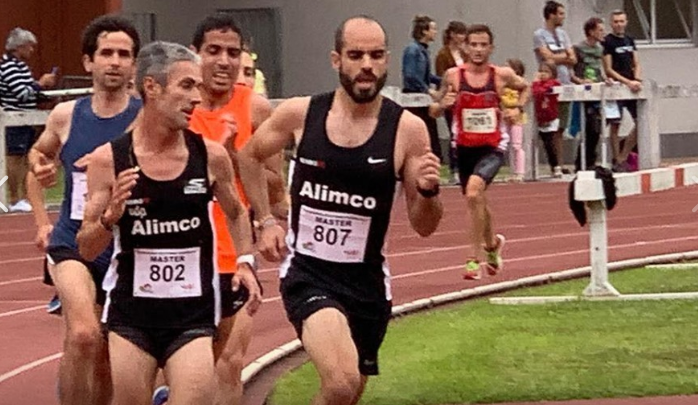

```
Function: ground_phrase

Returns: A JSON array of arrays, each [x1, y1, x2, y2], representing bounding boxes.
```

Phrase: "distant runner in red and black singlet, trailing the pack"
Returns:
[[424, 24, 529, 280]]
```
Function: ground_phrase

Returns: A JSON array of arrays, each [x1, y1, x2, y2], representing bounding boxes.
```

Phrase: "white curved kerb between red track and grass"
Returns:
[[242, 250, 698, 384]]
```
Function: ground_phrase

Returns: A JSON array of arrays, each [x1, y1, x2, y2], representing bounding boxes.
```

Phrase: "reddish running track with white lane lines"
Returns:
[[0, 183, 698, 405]]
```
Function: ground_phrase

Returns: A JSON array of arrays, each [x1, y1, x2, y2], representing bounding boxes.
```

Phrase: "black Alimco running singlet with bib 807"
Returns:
[[281, 93, 403, 300]]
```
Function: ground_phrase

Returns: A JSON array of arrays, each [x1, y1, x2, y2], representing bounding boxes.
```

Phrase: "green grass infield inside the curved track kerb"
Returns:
[[272, 268, 698, 405]]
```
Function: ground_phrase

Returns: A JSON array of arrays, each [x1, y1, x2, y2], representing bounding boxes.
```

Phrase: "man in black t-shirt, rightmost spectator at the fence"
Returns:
[[603, 10, 642, 170]]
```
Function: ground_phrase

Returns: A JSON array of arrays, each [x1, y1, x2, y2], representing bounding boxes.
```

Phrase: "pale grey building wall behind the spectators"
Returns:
[[122, 0, 698, 137]]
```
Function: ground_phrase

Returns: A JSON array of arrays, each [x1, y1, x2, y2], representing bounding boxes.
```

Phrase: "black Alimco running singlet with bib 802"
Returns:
[[104, 130, 219, 328]]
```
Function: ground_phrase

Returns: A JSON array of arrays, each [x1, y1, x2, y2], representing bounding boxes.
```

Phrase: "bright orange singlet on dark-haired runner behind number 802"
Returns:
[[189, 85, 254, 273]]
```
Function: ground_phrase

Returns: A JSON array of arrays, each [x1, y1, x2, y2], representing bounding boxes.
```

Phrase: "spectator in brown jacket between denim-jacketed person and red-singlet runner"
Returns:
[[434, 21, 468, 184]]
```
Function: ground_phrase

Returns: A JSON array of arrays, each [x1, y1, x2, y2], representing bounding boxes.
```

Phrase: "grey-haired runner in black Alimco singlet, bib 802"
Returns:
[[78, 42, 261, 405]]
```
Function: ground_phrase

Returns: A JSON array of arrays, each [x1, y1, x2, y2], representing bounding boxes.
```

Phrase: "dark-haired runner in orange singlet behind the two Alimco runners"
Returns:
[[174, 14, 283, 405]]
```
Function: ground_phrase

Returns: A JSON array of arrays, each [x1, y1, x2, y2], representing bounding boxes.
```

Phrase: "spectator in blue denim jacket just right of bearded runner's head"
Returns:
[[402, 15, 442, 158]]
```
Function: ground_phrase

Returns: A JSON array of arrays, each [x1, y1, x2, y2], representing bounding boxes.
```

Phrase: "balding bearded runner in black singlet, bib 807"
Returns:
[[235, 16, 442, 405]]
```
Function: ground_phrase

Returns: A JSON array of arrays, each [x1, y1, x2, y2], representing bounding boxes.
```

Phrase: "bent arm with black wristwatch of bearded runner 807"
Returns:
[[398, 112, 443, 237]]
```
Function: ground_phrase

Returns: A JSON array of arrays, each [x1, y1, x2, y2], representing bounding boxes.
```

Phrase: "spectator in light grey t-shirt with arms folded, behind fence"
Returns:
[[533, 0, 577, 177]]
